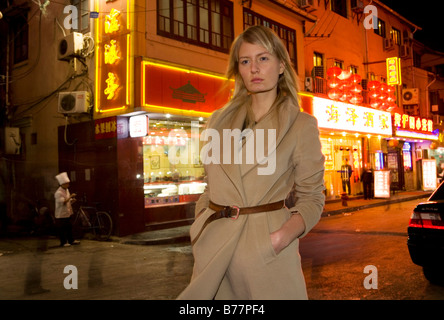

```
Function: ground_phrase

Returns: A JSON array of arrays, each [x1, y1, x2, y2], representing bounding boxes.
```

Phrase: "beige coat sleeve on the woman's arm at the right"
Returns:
[[290, 115, 325, 238]]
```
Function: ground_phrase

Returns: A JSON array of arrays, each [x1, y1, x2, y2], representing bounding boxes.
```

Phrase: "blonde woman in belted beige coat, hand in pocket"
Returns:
[[179, 26, 325, 300]]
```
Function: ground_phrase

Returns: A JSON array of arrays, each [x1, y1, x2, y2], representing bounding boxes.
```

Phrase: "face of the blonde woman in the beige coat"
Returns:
[[239, 42, 284, 93]]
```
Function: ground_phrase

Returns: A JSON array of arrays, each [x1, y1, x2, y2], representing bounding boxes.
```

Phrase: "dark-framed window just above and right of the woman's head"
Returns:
[[244, 8, 297, 72]]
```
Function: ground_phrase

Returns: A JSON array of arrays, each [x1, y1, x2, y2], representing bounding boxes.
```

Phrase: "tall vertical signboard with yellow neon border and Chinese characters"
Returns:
[[94, 0, 133, 114]]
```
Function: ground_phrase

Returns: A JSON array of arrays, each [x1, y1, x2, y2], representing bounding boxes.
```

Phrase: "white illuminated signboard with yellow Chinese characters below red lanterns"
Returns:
[[313, 97, 392, 136]]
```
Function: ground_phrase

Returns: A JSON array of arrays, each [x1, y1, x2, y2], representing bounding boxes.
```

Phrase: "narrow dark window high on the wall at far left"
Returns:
[[11, 12, 29, 64]]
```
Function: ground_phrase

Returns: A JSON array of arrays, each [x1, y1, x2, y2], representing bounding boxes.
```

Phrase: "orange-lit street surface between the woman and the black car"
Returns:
[[300, 200, 444, 300]]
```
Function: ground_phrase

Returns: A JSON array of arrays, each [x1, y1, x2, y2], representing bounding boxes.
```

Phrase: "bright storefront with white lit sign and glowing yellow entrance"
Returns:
[[302, 94, 392, 199]]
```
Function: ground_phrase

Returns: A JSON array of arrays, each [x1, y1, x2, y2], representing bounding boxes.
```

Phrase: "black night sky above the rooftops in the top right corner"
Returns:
[[380, 0, 444, 53]]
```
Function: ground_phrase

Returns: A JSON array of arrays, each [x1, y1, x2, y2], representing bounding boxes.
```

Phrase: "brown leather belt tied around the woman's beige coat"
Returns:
[[191, 200, 285, 245]]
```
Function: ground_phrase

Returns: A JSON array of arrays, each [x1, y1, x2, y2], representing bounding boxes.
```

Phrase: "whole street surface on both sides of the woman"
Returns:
[[0, 200, 444, 300]]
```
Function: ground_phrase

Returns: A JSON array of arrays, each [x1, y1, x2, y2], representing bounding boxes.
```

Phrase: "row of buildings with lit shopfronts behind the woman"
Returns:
[[0, 0, 444, 235]]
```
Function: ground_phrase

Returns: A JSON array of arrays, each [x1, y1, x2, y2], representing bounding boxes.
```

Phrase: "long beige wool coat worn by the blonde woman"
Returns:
[[178, 98, 325, 300]]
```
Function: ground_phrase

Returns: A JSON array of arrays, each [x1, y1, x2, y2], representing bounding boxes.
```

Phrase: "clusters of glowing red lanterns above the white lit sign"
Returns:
[[327, 66, 397, 111]]
